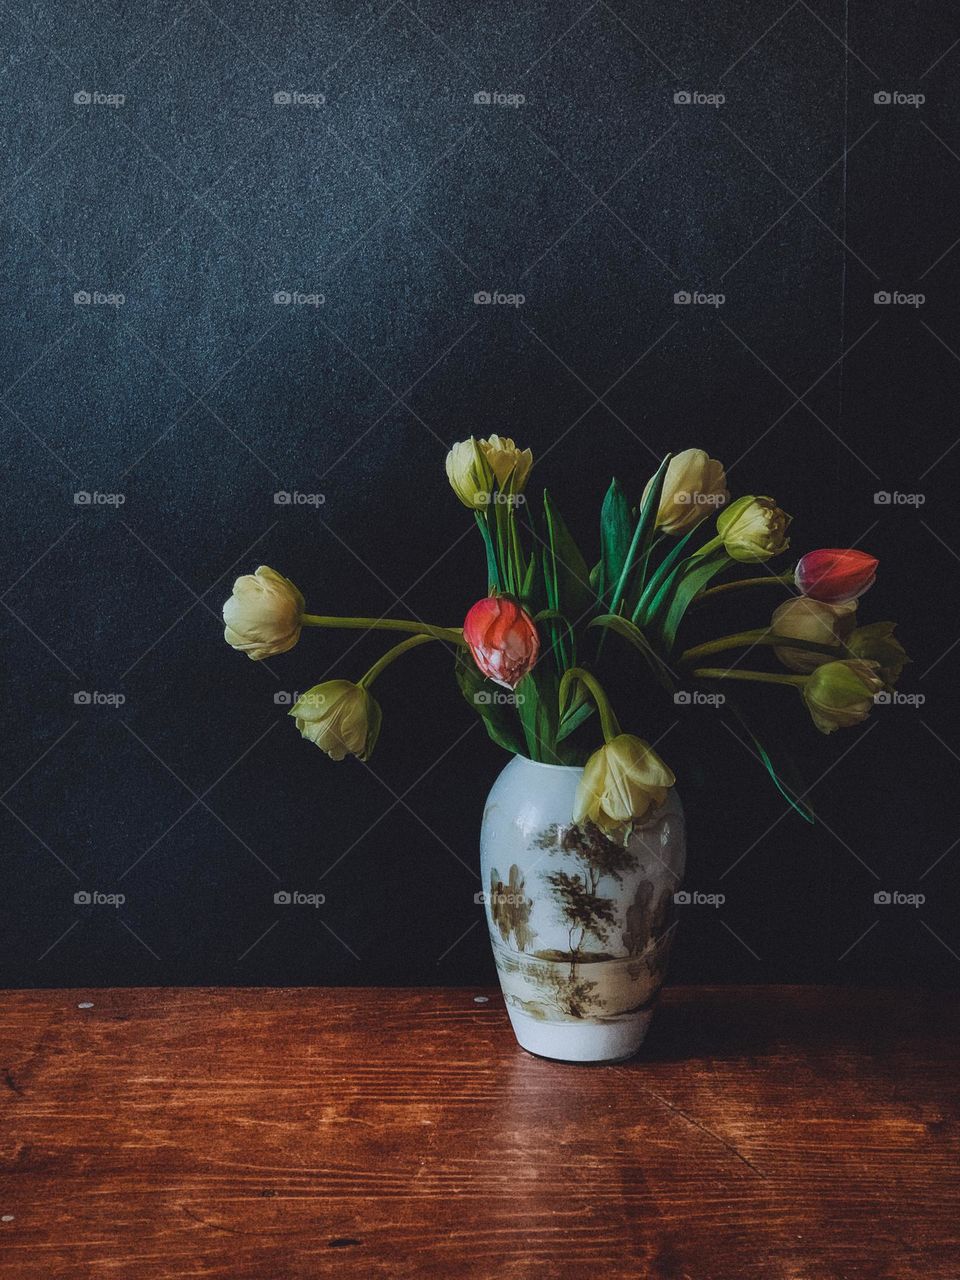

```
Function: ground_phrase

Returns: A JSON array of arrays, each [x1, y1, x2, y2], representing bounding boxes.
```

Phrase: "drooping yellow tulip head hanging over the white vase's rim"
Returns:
[[573, 733, 677, 831]]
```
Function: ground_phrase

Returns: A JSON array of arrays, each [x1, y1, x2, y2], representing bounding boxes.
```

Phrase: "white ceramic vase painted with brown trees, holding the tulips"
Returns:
[[480, 755, 686, 1062]]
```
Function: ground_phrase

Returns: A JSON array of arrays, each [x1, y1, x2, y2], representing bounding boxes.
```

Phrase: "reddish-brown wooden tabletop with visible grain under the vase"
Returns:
[[0, 987, 960, 1280]]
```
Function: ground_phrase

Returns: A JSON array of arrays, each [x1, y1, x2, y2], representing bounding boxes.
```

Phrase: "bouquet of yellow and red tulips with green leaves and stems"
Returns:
[[223, 435, 909, 832]]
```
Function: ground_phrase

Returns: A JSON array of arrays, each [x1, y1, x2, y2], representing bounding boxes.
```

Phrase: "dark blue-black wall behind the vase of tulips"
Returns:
[[0, 0, 960, 986]]
